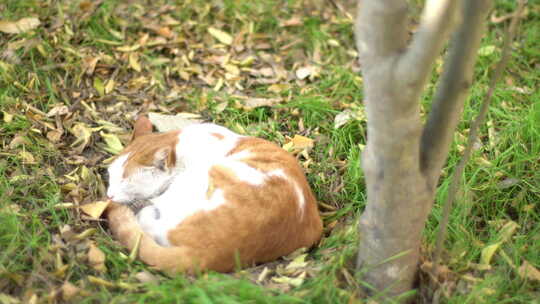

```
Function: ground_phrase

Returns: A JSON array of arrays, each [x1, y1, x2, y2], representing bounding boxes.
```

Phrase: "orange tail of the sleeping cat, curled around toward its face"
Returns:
[[107, 203, 213, 273]]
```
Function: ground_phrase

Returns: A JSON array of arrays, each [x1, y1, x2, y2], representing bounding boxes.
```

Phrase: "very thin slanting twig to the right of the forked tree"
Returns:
[[433, 0, 526, 278]]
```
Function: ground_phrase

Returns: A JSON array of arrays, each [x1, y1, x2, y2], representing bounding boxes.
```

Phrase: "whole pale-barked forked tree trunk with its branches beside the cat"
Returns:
[[356, 0, 491, 297]]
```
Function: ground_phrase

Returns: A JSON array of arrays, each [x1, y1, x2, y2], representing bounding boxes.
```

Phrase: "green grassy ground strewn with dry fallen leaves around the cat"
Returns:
[[0, 0, 540, 303]]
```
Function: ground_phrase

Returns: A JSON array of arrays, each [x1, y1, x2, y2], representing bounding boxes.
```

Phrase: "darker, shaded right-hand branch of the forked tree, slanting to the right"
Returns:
[[420, 0, 492, 183]]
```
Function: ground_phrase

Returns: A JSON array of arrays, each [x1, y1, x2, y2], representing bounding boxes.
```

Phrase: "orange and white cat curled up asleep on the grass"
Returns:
[[107, 117, 322, 272]]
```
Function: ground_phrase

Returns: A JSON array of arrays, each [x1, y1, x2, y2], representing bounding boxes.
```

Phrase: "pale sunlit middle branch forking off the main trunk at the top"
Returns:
[[397, 0, 462, 88]]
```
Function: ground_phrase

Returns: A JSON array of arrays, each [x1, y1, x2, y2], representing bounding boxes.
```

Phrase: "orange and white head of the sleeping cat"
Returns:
[[107, 116, 179, 204]]
